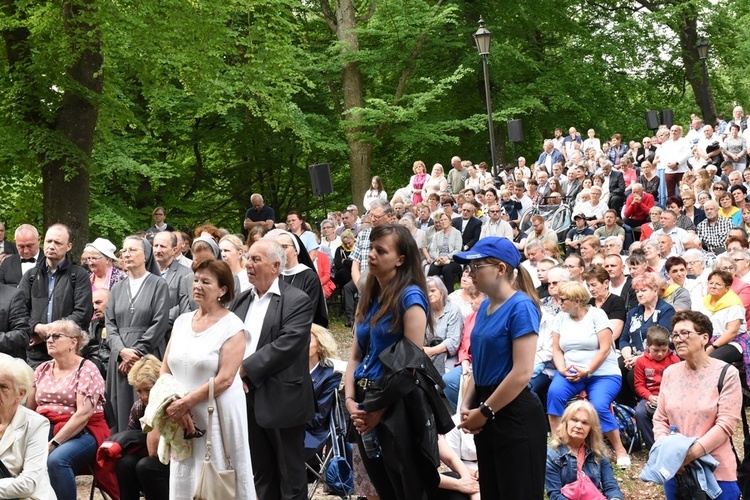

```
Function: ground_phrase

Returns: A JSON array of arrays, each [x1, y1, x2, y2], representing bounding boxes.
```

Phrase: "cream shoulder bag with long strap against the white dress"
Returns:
[[193, 377, 236, 500]]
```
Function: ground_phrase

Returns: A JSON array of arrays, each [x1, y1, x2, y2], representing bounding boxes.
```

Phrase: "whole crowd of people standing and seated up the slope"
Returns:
[[0, 109, 750, 500]]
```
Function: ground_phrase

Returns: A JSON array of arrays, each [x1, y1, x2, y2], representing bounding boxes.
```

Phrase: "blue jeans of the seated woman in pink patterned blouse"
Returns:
[[47, 432, 96, 499]]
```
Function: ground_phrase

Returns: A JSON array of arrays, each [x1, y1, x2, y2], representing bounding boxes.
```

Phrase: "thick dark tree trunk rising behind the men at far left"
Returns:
[[42, 0, 103, 259]]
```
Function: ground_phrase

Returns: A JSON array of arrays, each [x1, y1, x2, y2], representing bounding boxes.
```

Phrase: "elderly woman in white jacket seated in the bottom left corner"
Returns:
[[0, 354, 55, 499]]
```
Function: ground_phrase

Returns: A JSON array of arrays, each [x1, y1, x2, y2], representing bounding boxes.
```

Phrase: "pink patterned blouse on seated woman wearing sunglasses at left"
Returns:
[[34, 360, 104, 415]]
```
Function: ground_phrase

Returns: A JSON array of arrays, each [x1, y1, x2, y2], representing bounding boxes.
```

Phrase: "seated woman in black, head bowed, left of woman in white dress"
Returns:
[[115, 354, 169, 500]]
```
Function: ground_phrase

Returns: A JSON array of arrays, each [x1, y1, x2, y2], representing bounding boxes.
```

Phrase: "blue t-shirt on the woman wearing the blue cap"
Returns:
[[471, 292, 540, 387]]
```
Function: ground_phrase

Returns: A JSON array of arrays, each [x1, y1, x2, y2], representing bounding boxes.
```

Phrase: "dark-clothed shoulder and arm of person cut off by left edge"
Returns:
[[0, 285, 31, 361]]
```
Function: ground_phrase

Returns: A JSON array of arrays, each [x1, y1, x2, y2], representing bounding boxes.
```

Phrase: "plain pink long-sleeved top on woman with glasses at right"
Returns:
[[654, 358, 742, 481]]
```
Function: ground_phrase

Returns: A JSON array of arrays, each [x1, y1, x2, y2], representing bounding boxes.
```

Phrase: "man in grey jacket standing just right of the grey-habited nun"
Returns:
[[153, 231, 196, 329]]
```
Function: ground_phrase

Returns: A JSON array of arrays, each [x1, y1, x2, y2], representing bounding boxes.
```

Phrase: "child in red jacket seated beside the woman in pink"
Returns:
[[633, 325, 680, 450]]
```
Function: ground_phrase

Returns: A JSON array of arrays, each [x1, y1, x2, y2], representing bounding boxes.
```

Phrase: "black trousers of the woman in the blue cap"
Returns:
[[474, 387, 547, 500]]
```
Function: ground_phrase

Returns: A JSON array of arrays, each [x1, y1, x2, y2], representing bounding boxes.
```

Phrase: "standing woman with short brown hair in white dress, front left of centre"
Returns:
[[161, 260, 255, 499]]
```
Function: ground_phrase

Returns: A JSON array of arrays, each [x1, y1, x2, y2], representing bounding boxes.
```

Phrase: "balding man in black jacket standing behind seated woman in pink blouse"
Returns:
[[18, 224, 94, 368]]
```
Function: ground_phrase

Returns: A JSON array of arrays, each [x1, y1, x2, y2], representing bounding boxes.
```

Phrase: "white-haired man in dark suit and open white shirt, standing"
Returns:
[[232, 239, 315, 500]]
